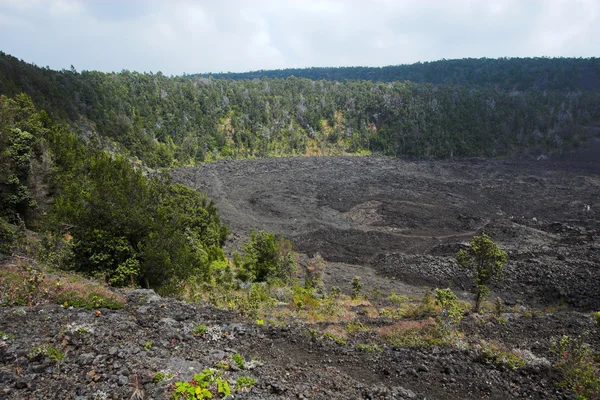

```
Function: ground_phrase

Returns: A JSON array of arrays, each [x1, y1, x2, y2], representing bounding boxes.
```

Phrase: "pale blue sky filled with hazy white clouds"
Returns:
[[0, 0, 600, 75]]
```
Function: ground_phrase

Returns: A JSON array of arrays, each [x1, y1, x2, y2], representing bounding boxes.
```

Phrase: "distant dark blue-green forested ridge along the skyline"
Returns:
[[197, 58, 600, 91]]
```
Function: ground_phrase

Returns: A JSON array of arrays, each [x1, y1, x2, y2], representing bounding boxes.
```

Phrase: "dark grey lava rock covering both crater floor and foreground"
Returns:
[[0, 157, 600, 400]]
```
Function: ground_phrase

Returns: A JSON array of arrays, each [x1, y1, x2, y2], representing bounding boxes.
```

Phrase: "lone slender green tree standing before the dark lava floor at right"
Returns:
[[456, 233, 507, 312]]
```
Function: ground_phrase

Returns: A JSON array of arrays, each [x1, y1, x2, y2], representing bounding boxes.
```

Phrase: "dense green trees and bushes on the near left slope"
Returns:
[[0, 94, 228, 292]]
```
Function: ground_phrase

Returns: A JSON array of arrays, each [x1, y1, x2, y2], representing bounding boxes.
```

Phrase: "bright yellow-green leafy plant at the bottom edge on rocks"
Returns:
[[171, 368, 231, 400]]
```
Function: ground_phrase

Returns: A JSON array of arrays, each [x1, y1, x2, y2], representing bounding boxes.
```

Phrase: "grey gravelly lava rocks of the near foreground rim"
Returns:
[[0, 290, 598, 400]]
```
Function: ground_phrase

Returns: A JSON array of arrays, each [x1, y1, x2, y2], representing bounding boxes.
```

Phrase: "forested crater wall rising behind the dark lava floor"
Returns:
[[0, 53, 600, 167]]
